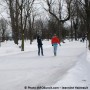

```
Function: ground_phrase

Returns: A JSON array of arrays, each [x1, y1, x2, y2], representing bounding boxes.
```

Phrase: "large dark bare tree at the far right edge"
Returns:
[[73, 0, 90, 49]]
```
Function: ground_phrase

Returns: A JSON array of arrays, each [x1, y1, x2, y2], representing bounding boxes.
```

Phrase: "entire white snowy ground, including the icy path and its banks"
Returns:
[[0, 41, 90, 90]]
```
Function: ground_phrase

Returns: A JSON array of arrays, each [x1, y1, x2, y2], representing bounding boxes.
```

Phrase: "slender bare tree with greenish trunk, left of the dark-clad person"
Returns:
[[20, 0, 35, 51]]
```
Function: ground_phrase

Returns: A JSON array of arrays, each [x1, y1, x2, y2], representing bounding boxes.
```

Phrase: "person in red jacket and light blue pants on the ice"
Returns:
[[51, 34, 60, 56]]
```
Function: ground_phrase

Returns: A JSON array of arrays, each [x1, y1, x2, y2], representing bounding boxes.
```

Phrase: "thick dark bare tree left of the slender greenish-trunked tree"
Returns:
[[5, 0, 20, 44]]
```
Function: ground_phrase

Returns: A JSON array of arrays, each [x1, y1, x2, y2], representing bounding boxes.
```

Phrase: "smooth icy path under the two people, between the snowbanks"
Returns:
[[0, 42, 86, 90]]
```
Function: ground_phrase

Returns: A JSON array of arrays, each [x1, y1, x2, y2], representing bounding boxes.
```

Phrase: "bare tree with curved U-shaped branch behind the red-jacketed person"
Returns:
[[41, 0, 72, 38]]
